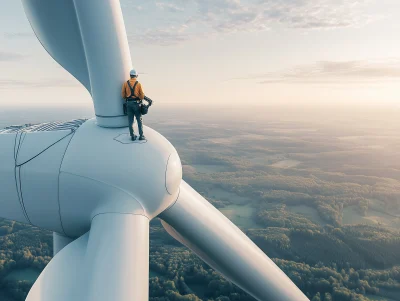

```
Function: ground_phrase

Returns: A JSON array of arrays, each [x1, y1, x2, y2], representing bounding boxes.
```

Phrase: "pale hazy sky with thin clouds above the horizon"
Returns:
[[0, 0, 400, 110]]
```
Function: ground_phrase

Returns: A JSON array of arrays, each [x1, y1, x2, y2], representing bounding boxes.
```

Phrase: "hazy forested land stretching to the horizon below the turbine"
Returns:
[[0, 107, 400, 301]]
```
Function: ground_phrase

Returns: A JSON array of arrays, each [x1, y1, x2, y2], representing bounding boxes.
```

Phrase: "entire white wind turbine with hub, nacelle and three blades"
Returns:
[[0, 0, 308, 301]]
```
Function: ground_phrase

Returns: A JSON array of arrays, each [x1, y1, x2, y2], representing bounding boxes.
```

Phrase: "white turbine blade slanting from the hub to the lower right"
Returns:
[[160, 181, 308, 301]]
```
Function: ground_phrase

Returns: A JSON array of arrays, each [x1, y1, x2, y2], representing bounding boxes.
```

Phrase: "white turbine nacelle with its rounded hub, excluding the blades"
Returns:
[[0, 119, 182, 237]]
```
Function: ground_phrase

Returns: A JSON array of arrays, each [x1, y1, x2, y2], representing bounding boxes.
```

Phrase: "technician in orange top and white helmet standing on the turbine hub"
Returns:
[[122, 69, 146, 141]]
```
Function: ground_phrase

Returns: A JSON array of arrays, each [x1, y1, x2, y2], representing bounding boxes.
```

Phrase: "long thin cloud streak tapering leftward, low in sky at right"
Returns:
[[231, 58, 400, 84]]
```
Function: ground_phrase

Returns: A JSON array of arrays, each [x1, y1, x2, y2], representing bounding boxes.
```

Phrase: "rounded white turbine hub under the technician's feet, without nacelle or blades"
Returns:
[[60, 119, 182, 232]]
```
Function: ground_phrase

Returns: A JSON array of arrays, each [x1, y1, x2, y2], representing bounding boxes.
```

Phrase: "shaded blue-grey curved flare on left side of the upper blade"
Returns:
[[22, 0, 91, 92]]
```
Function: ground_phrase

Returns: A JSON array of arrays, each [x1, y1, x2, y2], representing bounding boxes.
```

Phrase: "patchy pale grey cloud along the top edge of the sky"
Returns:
[[123, 0, 378, 45]]
